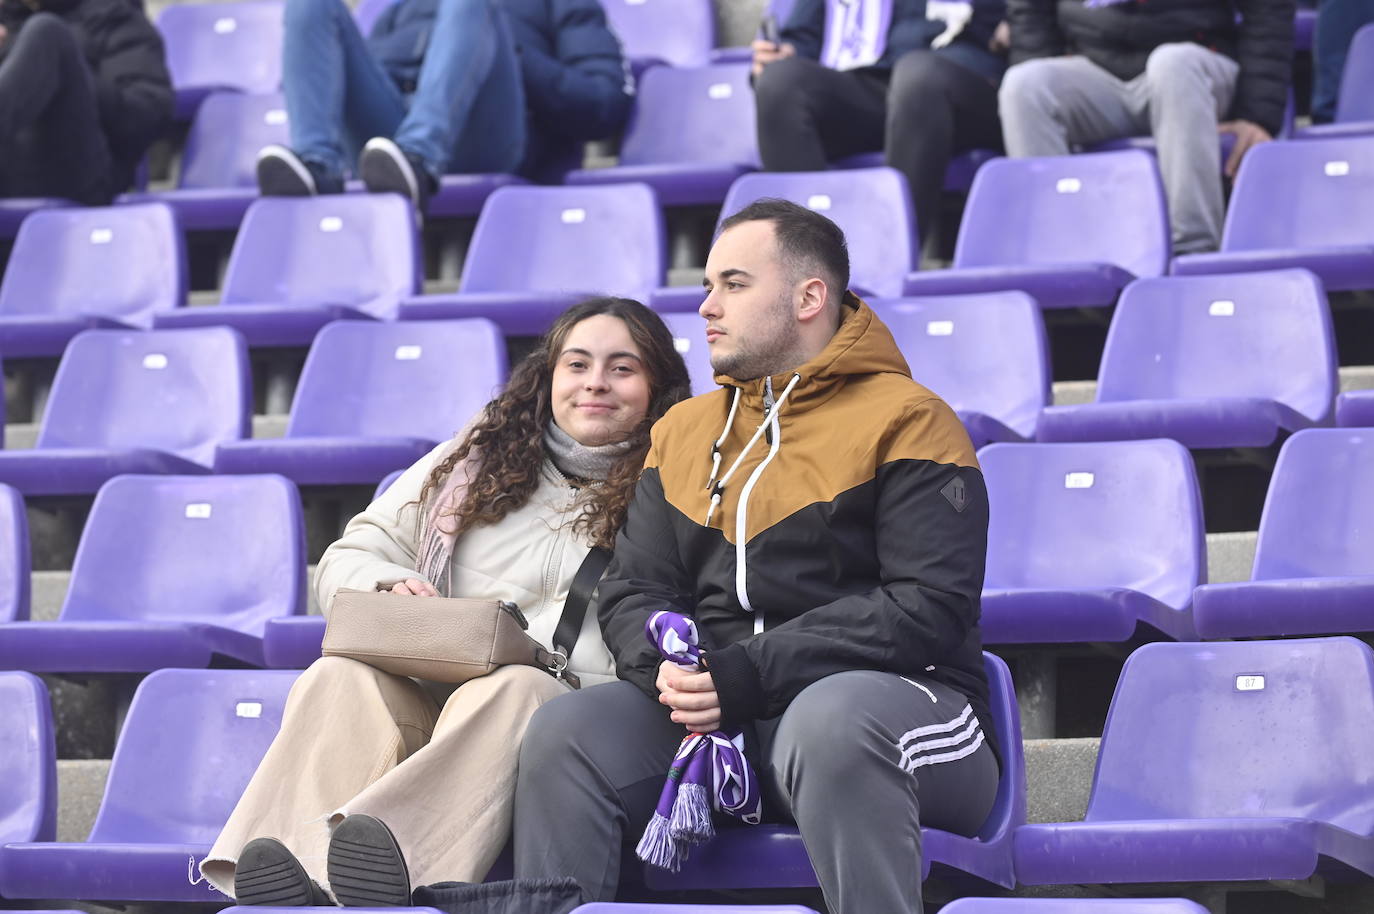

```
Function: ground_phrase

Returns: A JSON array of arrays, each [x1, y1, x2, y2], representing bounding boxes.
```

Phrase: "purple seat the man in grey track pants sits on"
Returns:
[[644, 653, 1026, 889]]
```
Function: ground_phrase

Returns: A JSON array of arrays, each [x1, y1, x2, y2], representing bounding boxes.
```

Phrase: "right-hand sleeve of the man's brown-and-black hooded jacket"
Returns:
[[705, 400, 988, 724]]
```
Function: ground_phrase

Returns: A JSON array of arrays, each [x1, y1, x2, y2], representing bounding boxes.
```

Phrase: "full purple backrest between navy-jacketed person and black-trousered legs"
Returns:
[[620, 63, 758, 165]]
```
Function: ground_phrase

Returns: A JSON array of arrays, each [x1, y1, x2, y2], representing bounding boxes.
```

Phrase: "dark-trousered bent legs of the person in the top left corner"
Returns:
[[0, 12, 120, 205]]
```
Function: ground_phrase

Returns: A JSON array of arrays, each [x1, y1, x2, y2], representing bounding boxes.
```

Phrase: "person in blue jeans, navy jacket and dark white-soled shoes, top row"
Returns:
[[258, 0, 632, 210]]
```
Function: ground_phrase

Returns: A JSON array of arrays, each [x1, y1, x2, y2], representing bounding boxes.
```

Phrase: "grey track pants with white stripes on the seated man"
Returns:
[[515, 671, 998, 914]]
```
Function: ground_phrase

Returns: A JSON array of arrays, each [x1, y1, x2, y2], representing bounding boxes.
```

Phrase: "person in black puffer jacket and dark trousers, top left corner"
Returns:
[[0, 0, 172, 205]]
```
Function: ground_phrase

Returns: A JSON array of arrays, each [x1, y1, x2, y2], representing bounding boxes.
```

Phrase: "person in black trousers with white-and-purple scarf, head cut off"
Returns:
[[753, 0, 1006, 250]]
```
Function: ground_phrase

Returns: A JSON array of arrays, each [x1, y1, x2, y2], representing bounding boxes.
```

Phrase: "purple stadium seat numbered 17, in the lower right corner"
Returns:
[[1015, 638, 1374, 885]]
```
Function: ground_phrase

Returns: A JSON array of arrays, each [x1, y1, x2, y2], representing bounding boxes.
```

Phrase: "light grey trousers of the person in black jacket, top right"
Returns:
[[998, 43, 1241, 254]]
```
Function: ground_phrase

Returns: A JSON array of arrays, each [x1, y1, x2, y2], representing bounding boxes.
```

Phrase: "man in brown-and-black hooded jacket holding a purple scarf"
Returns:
[[515, 201, 999, 914]]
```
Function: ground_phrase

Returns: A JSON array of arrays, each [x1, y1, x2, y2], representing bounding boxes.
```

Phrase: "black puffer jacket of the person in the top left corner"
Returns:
[[0, 0, 172, 191]]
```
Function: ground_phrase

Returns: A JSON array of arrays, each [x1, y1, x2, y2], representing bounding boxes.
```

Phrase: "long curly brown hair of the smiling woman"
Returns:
[[419, 297, 691, 548]]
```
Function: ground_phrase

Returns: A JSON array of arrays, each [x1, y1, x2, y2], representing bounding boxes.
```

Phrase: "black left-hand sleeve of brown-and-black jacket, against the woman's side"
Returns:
[[596, 454, 694, 698]]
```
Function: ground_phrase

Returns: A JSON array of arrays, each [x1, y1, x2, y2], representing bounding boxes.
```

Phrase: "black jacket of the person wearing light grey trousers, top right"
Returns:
[[1007, 0, 1294, 135]]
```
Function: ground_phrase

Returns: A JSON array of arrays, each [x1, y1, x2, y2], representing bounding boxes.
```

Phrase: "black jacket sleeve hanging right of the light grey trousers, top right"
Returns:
[[1231, 0, 1294, 136]]
